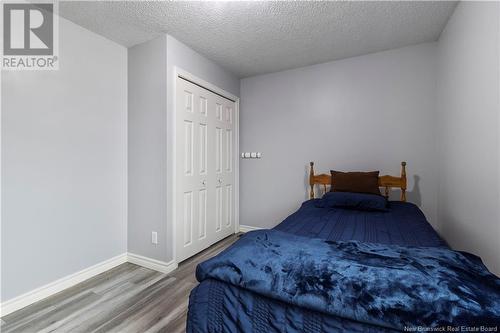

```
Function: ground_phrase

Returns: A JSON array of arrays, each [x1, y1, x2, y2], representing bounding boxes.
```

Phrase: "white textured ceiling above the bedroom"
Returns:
[[59, 1, 456, 77]]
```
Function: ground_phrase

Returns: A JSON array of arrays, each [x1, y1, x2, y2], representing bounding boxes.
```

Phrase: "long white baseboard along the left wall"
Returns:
[[0, 253, 127, 316]]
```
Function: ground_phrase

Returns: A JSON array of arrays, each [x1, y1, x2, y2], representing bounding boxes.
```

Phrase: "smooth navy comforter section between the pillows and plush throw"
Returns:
[[274, 199, 447, 247]]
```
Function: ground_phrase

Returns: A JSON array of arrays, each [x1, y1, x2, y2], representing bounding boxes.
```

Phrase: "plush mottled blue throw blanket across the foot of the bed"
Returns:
[[196, 230, 500, 329]]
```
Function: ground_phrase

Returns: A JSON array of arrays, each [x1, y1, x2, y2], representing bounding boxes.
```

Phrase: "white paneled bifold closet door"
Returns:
[[175, 77, 235, 262]]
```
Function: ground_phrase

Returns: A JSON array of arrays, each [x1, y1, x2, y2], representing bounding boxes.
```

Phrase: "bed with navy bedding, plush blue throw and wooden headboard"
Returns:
[[187, 162, 500, 332]]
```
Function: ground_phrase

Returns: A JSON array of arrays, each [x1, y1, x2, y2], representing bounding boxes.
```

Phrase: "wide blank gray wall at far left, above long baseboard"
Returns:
[[1, 18, 127, 301]]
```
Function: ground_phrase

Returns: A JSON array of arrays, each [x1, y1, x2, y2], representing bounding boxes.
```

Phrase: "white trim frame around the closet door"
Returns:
[[171, 66, 240, 264]]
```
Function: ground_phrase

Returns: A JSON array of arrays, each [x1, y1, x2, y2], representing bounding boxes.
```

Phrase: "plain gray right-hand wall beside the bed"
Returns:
[[437, 2, 500, 274]]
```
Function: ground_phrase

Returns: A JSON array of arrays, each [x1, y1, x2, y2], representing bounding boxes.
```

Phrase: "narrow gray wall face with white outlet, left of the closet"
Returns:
[[128, 36, 170, 260]]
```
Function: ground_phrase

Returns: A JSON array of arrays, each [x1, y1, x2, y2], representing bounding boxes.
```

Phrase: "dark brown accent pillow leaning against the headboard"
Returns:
[[330, 170, 381, 195]]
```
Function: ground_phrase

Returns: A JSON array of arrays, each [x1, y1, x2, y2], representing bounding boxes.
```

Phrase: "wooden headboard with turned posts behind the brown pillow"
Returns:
[[309, 162, 406, 201]]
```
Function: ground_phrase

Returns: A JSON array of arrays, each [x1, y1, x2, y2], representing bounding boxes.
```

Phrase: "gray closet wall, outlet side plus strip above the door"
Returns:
[[128, 35, 239, 262]]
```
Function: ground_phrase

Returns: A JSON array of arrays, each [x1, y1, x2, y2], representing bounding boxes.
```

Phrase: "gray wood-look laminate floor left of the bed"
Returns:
[[0, 235, 238, 333]]
